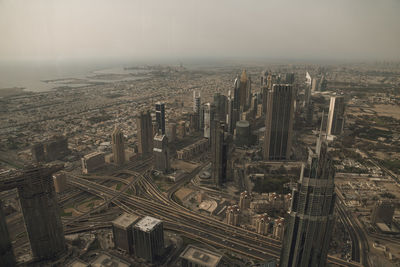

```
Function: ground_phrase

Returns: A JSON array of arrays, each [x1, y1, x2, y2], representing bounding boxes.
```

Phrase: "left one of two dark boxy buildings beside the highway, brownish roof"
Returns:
[[112, 213, 139, 254]]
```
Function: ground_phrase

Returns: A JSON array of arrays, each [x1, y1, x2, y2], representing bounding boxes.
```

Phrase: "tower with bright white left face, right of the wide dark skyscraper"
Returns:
[[326, 96, 346, 135]]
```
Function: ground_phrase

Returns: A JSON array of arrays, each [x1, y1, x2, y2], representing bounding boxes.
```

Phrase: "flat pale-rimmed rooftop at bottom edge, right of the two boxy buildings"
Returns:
[[180, 245, 222, 267]]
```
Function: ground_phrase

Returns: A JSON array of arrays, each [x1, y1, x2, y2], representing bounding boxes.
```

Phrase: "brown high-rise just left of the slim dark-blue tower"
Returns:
[[136, 110, 153, 155]]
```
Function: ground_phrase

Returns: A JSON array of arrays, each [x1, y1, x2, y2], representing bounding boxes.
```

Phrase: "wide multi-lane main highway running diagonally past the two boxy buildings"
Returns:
[[70, 175, 360, 266]]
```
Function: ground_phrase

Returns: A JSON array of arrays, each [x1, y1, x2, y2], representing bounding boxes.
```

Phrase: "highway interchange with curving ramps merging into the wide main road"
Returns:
[[63, 158, 361, 266]]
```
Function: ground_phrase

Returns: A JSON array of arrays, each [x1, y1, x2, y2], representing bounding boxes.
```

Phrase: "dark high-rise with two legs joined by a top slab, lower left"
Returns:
[[0, 166, 66, 266]]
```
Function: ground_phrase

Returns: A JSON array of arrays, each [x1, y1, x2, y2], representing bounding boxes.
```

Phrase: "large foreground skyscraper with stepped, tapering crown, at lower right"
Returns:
[[280, 142, 336, 267]]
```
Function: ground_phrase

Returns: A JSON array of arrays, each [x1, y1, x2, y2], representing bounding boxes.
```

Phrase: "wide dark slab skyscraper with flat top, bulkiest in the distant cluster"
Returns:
[[263, 84, 295, 160]]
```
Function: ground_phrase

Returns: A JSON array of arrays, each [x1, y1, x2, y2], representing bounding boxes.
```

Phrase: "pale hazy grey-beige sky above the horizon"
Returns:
[[0, 0, 400, 61]]
